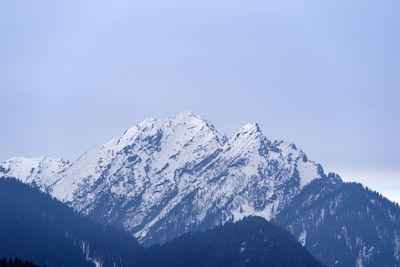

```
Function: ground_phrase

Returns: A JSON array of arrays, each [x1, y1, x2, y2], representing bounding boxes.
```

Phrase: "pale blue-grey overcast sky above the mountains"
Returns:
[[0, 0, 400, 201]]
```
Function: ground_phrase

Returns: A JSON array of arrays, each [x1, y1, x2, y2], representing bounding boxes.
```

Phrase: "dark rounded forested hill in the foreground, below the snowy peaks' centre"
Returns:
[[145, 217, 322, 267]]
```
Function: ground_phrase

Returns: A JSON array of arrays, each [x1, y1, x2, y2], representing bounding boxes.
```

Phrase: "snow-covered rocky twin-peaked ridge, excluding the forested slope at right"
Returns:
[[0, 112, 329, 244]]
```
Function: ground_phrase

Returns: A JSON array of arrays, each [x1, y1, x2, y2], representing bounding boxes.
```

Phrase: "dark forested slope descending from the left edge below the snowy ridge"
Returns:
[[0, 179, 143, 267]]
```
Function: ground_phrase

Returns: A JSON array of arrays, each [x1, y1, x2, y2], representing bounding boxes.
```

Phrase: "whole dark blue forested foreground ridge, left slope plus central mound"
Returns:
[[0, 179, 321, 267]]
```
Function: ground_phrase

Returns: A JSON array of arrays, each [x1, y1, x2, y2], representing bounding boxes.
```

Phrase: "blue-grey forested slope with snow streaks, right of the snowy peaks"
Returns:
[[274, 180, 400, 266]]
